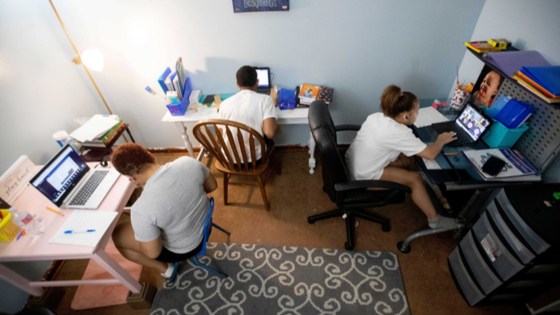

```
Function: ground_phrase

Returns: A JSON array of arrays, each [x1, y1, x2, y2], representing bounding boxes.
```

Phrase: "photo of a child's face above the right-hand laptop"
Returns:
[[469, 65, 504, 107]]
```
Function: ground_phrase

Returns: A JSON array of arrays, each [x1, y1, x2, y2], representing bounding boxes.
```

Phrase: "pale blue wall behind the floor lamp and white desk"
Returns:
[[0, 0, 484, 314]]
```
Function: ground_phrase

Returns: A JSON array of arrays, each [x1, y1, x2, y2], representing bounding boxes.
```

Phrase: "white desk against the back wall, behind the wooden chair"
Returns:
[[161, 106, 315, 174]]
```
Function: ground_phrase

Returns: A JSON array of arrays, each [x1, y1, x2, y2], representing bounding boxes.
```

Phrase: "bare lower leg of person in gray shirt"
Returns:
[[113, 214, 169, 273]]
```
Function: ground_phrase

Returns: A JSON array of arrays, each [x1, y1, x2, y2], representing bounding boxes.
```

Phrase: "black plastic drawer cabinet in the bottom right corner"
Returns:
[[448, 184, 560, 306]]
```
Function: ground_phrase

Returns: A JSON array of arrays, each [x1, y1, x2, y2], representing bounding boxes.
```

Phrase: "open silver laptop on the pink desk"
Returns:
[[30, 145, 120, 209]]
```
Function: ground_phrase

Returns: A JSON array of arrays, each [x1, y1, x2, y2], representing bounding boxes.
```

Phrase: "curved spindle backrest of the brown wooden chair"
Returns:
[[193, 119, 267, 171]]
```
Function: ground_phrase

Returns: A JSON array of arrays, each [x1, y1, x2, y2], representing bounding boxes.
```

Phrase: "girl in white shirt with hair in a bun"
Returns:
[[346, 85, 457, 229]]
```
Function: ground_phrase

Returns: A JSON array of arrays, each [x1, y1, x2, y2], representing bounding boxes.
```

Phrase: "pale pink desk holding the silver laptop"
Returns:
[[0, 167, 142, 296]]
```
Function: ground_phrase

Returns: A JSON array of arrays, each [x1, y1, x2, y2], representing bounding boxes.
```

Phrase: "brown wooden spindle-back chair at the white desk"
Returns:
[[193, 119, 280, 211]]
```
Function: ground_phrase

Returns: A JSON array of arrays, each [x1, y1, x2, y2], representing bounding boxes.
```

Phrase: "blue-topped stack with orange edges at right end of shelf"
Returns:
[[513, 66, 560, 103]]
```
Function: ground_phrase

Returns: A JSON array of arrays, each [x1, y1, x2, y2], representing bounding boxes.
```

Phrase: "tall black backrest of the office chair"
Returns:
[[309, 101, 349, 202]]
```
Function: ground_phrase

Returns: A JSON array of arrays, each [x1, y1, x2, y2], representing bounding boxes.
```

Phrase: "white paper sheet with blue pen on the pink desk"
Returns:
[[49, 210, 118, 246]]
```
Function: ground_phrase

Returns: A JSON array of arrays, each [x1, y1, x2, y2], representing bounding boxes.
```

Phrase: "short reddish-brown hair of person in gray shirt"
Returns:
[[111, 143, 156, 176]]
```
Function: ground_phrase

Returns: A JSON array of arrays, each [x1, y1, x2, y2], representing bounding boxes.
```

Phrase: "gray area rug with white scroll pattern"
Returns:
[[151, 243, 410, 315]]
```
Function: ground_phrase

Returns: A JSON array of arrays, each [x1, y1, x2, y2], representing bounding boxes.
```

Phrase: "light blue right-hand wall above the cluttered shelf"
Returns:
[[452, 0, 560, 182]]
